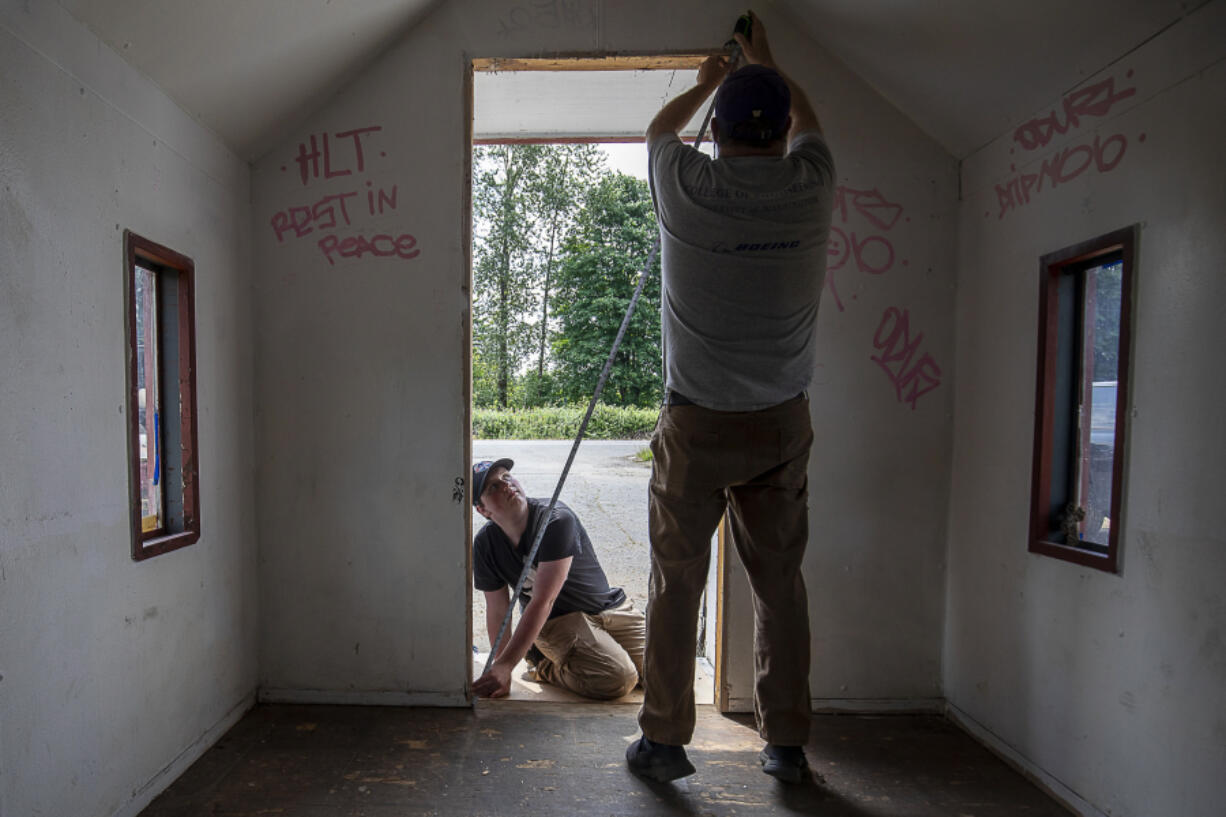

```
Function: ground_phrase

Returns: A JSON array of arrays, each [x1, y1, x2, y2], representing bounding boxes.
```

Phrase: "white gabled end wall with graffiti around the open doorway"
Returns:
[[253, 0, 956, 703]]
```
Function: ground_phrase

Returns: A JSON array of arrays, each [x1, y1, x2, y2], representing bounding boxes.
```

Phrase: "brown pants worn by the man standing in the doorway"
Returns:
[[639, 396, 813, 746]]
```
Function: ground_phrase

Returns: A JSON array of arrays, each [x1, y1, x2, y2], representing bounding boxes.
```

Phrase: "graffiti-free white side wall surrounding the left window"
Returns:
[[0, 6, 257, 817]]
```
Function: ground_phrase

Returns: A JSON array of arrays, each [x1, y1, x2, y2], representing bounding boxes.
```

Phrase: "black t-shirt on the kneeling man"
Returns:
[[472, 499, 625, 618]]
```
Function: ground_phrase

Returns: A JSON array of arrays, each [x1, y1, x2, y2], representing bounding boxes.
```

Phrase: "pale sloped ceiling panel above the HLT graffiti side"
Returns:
[[60, 0, 438, 159]]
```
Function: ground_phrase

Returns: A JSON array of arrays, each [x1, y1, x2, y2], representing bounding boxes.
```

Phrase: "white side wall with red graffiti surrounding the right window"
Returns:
[[944, 2, 1226, 817]]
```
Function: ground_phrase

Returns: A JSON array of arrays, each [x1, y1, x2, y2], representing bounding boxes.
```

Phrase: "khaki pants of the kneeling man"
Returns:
[[536, 599, 645, 700]]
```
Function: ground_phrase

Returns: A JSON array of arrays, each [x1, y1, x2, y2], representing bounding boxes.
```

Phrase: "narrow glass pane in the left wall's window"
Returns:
[[135, 266, 166, 532]]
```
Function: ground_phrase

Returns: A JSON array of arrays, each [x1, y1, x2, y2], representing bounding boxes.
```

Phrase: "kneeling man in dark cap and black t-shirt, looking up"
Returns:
[[472, 459, 644, 699]]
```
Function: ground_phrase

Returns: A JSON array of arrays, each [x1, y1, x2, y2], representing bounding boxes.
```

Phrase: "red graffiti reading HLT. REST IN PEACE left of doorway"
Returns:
[[271, 125, 422, 265]]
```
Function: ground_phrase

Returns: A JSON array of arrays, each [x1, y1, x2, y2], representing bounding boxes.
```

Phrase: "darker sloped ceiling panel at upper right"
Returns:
[[791, 0, 1201, 158]]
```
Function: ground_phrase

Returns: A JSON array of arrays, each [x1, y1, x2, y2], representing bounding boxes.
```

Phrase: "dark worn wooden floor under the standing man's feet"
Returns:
[[142, 700, 1068, 817]]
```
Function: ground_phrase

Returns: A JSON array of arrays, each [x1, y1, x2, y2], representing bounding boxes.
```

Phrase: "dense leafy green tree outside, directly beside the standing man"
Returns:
[[553, 173, 662, 406]]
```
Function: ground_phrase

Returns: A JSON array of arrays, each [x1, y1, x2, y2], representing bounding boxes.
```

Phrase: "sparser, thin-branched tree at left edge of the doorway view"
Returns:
[[472, 145, 543, 407]]
